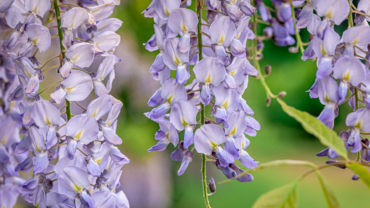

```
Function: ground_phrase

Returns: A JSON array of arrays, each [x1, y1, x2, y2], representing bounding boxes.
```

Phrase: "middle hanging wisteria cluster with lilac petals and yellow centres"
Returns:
[[143, 0, 260, 182]]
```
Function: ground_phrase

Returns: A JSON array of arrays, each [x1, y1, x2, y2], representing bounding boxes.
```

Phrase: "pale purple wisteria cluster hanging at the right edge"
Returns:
[[297, 0, 370, 166]]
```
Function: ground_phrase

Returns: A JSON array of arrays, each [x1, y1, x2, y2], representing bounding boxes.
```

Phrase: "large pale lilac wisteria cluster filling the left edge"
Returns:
[[0, 0, 129, 208]]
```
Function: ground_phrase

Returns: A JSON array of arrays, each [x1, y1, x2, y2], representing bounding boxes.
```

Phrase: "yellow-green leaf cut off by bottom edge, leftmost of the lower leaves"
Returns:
[[253, 181, 299, 208]]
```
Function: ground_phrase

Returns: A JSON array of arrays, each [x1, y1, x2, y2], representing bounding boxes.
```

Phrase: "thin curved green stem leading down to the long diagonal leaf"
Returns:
[[251, 14, 277, 98]]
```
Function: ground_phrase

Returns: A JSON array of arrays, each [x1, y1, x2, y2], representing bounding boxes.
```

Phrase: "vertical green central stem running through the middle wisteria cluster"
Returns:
[[196, 0, 211, 208]]
